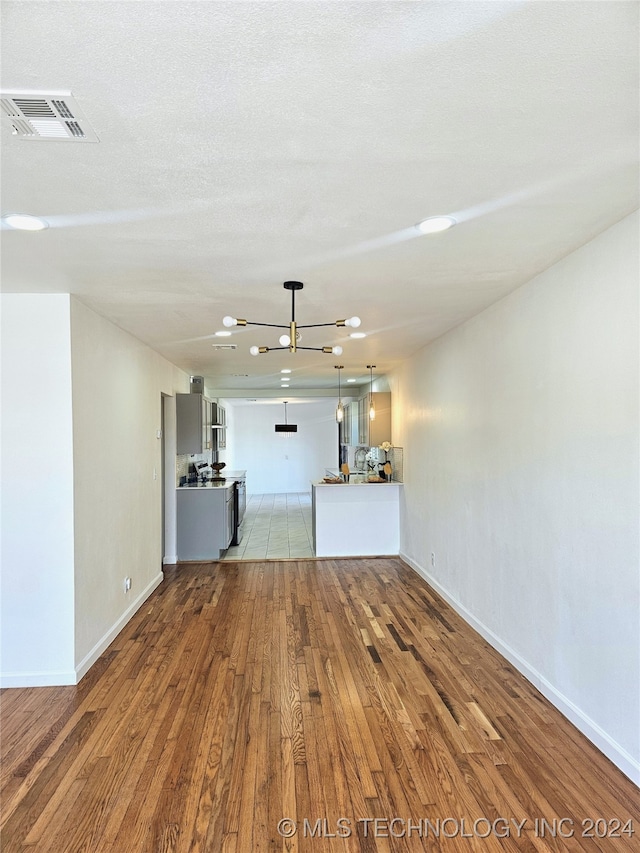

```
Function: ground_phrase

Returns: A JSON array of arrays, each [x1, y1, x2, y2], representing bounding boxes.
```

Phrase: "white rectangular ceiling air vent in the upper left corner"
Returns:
[[0, 89, 99, 142]]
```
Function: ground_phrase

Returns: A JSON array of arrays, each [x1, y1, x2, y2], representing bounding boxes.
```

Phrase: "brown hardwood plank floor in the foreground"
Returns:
[[1, 558, 640, 853]]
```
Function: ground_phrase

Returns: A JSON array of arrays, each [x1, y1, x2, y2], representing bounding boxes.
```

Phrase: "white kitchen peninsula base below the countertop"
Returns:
[[311, 482, 402, 557]]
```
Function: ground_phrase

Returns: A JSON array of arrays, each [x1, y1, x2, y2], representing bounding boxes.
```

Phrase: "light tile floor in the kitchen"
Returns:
[[223, 492, 313, 560]]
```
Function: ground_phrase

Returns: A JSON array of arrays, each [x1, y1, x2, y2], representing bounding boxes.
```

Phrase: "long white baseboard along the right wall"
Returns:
[[400, 553, 640, 785]]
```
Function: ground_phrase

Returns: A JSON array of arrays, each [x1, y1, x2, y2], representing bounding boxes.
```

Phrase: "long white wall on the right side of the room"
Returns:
[[391, 214, 640, 780]]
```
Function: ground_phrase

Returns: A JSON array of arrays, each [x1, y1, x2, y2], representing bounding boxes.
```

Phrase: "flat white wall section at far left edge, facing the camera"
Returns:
[[0, 294, 75, 687]]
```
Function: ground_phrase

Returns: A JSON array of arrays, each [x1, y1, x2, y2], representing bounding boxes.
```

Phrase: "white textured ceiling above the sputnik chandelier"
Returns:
[[1, 0, 639, 392]]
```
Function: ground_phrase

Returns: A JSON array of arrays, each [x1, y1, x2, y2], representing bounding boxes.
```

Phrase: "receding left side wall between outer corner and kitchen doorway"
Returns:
[[71, 299, 189, 675]]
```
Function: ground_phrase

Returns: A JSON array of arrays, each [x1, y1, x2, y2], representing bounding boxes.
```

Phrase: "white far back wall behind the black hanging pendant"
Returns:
[[226, 398, 338, 494]]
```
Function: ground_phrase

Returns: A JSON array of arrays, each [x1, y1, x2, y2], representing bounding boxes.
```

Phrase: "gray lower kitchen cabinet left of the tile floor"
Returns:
[[176, 482, 234, 561]]
